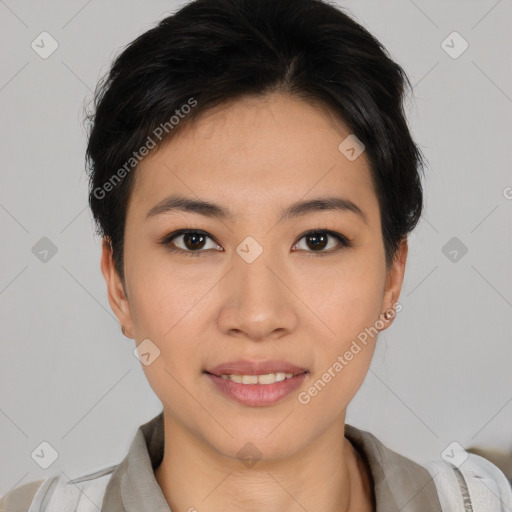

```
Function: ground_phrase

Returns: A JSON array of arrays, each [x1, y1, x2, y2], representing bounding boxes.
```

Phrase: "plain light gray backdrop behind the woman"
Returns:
[[0, 0, 512, 495]]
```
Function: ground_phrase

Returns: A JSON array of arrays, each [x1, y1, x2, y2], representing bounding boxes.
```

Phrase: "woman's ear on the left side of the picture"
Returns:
[[101, 237, 132, 338]]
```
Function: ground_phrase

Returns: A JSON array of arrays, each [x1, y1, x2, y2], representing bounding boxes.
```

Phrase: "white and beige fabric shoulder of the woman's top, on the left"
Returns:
[[0, 465, 117, 512]]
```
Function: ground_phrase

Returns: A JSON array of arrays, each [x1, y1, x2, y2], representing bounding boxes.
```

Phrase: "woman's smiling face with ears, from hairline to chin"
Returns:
[[102, 93, 407, 459]]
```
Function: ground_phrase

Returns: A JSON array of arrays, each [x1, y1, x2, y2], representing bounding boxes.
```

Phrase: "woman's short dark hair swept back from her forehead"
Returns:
[[86, 0, 424, 283]]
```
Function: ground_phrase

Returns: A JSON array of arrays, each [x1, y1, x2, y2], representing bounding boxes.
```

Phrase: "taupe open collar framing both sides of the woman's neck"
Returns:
[[102, 412, 441, 512]]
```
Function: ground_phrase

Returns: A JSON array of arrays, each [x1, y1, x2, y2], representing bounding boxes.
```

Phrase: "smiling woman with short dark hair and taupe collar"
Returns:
[[2, 0, 512, 512]]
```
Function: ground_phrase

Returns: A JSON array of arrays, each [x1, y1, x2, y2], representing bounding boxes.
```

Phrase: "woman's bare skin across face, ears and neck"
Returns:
[[101, 92, 407, 512]]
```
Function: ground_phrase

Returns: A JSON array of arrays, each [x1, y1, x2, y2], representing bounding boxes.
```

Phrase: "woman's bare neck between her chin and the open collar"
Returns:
[[155, 413, 373, 512]]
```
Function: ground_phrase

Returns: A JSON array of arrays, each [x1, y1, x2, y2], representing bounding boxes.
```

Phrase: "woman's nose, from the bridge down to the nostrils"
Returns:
[[217, 247, 300, 341]]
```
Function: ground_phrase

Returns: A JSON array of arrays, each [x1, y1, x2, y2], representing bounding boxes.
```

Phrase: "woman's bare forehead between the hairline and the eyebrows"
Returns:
[[128, 93, 378, 224]]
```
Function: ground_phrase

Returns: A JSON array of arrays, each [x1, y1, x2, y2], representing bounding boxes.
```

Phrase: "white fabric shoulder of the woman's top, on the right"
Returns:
[[425, 452, 512, 512]]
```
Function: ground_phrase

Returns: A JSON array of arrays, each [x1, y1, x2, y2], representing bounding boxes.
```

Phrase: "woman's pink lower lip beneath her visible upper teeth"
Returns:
[[206, 373, 306, 406]]
